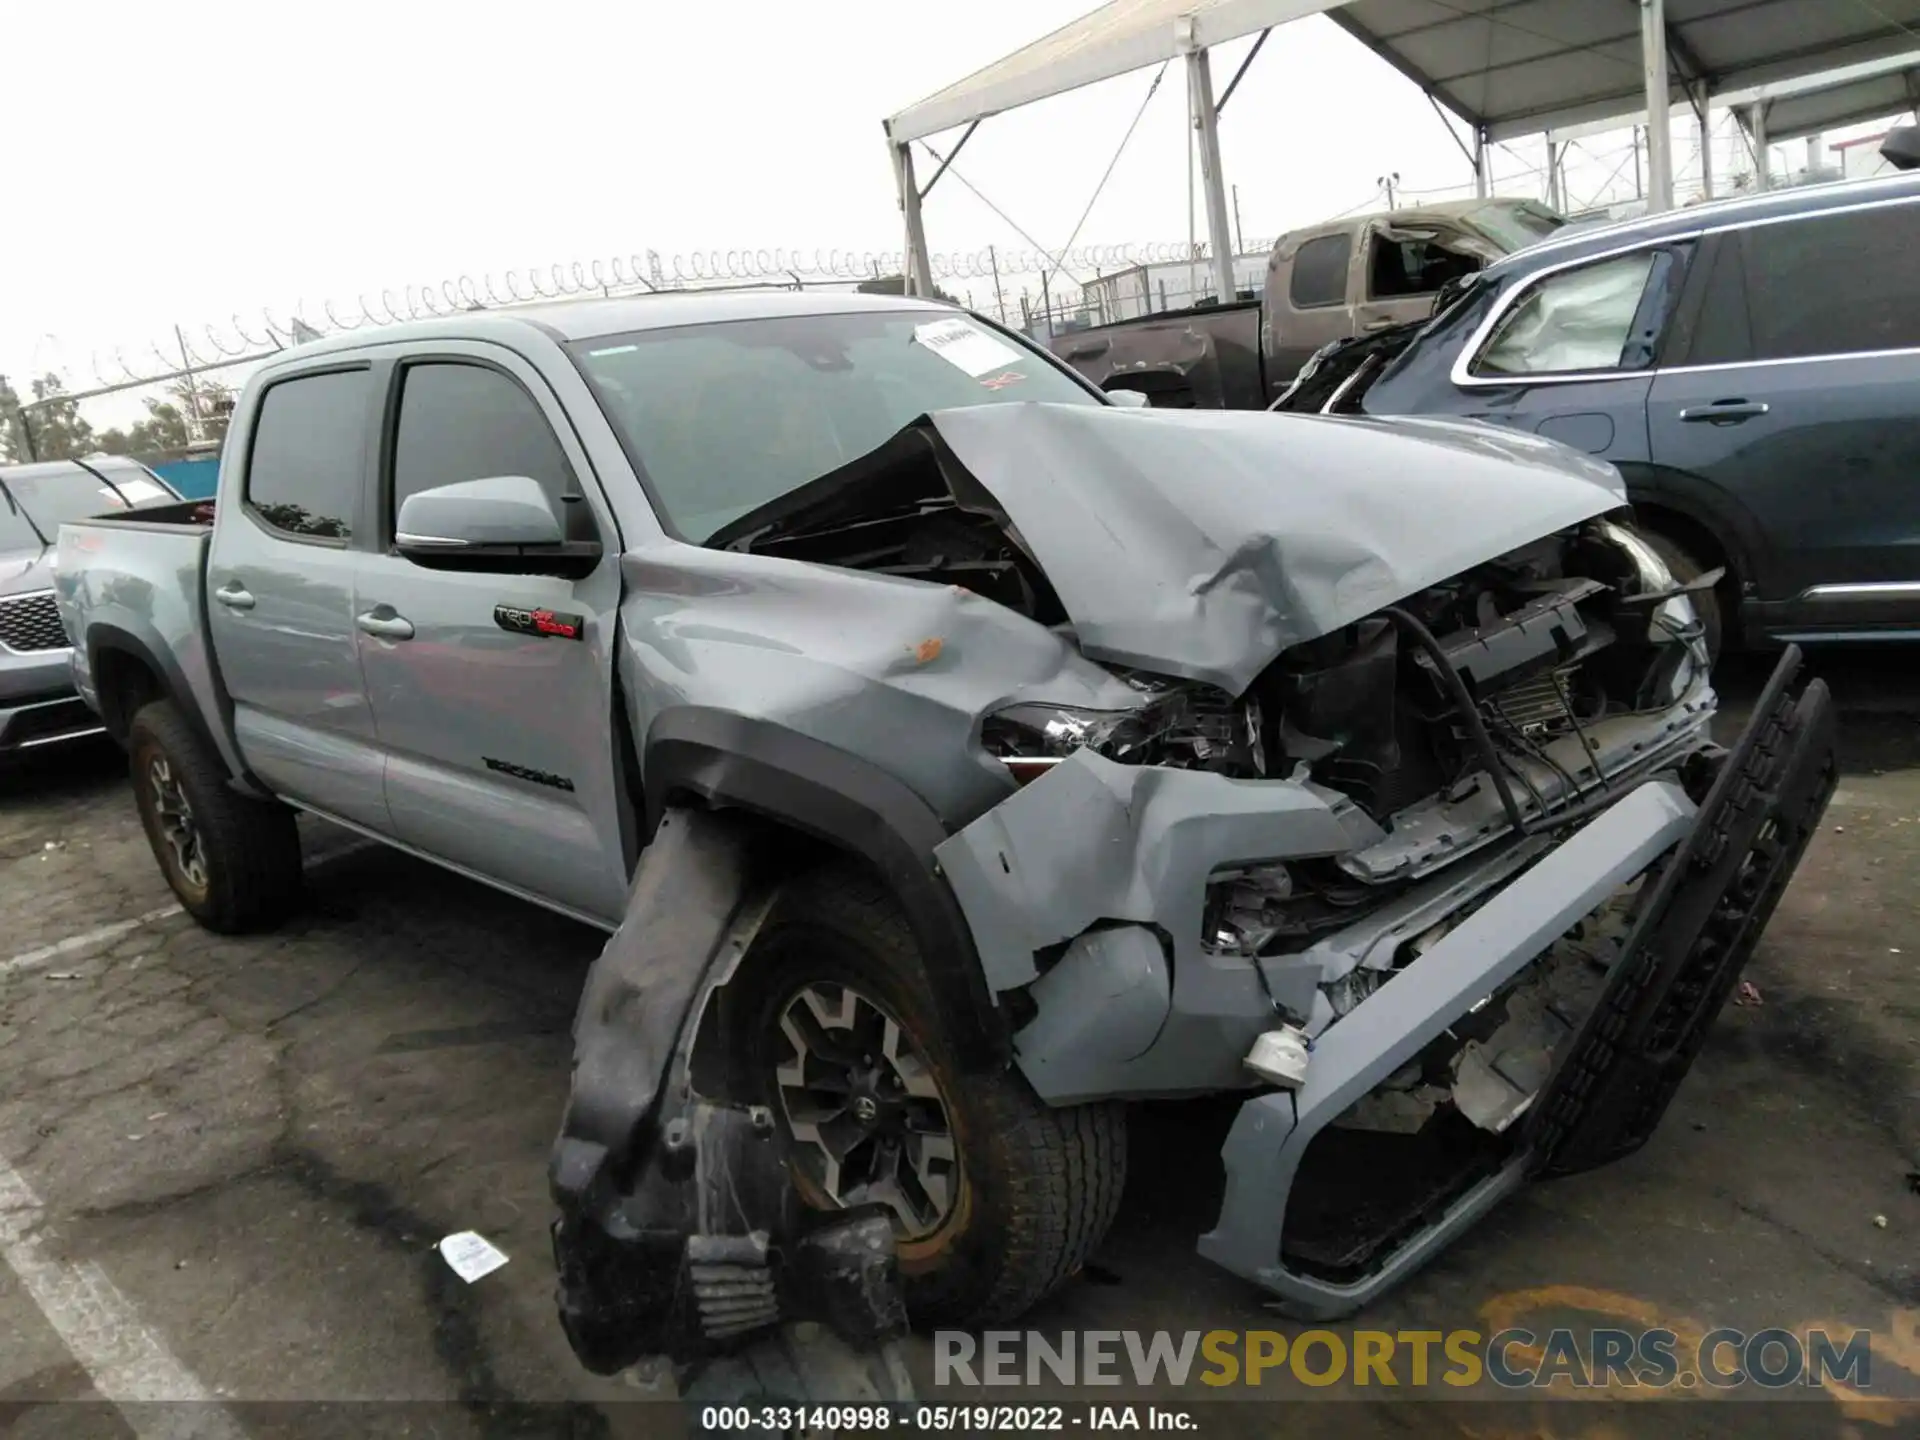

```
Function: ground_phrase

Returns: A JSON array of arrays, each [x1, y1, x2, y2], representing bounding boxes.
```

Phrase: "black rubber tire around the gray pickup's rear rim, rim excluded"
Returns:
[[127, 701, 301, 935]]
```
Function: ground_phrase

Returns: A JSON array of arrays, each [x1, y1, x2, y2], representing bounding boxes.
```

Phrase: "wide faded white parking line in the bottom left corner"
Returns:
[[0, 1156, 244, 1440]]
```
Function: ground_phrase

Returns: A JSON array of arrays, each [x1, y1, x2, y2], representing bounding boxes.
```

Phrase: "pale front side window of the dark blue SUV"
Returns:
[[1473, 250, 1659, 378]]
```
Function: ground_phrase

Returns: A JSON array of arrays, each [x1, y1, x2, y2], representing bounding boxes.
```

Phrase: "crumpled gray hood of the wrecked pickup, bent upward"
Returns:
[[927, 403, 1626, 695]]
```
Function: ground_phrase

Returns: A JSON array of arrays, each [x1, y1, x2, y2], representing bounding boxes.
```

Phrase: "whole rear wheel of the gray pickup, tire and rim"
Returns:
[[127, 701, 301, 935]]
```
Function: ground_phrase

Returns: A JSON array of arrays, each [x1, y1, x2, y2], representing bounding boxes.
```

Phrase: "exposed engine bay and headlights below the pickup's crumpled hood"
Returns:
[[983, 520, 1695, 826]]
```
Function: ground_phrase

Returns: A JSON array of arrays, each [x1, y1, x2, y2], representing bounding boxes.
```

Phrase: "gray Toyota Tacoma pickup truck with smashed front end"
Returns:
[[58, 294, 1834, 1369]]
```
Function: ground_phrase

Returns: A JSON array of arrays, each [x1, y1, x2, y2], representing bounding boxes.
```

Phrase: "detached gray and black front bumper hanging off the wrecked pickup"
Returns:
[[1200, 647, 1836, 1319]]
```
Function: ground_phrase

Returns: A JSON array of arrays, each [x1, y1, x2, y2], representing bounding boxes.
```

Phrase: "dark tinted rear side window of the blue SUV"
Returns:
[[1740, 202, 1920, 359]]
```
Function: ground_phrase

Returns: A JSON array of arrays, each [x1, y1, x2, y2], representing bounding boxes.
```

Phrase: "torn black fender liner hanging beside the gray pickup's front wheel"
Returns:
[[547, 810, 906, 1375]]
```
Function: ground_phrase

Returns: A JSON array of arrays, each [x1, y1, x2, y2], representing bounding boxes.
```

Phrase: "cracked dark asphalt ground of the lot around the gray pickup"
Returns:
[[0, 651, 1920, 1440]]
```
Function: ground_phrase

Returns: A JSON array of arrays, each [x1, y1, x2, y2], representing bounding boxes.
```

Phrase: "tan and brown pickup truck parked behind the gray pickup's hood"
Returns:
[[1052, 200, 1565, 411]]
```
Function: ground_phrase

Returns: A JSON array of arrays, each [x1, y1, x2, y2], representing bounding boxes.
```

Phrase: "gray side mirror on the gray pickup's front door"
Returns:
[[394, 474, 601, 580]]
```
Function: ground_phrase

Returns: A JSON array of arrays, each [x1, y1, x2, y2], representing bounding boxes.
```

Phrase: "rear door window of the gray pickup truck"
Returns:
[[246, 371, 372, 541]]
